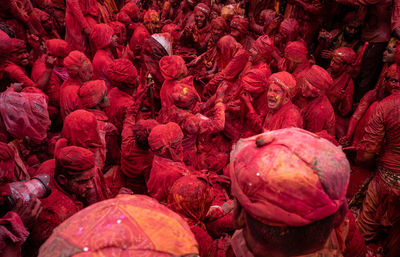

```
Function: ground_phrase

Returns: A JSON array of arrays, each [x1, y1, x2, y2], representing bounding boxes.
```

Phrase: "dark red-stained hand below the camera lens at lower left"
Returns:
[[12, 197, 43, 228]]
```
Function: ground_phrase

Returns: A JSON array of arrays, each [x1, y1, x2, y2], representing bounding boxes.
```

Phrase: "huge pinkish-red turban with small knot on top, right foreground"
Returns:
[[230, 128, 350, 227]]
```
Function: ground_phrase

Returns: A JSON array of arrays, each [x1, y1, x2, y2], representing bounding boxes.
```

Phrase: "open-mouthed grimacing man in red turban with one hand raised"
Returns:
[[242, 71, 303, 133]]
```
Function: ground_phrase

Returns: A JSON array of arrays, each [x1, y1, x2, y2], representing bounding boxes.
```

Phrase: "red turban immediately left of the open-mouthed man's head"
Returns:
[[242, 66, 271, 94]]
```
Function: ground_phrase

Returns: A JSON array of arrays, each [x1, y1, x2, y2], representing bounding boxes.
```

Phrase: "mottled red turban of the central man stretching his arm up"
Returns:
[[172, 83, 201, 108]]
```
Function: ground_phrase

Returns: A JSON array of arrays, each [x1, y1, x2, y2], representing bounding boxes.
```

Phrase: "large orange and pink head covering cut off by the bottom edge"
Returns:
[[39, 195, 199, 257]]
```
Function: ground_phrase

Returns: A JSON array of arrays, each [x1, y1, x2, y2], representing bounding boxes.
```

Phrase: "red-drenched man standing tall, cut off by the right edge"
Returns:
[[357, 64, 400, 257]]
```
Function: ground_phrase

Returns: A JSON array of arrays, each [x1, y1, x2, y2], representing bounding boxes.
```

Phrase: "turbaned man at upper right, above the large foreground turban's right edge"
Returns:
[[326, 47, 356, 138]]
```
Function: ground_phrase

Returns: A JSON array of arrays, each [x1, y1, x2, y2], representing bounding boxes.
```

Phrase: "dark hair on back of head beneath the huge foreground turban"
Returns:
[[246, 209, 340, 256]]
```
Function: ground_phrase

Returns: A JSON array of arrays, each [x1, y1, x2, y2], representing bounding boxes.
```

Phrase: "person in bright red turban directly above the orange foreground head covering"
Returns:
[[147, 122, 190, 203]]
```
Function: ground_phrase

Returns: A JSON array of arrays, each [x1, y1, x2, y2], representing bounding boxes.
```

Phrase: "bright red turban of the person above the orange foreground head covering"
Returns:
[[148, 122, 183, 151]]
